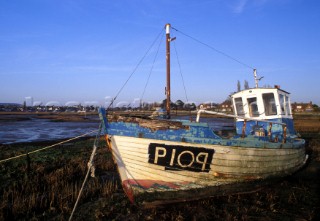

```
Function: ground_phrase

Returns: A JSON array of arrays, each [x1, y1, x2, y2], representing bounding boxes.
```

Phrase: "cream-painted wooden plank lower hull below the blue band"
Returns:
[[109, 135, 306, 206]]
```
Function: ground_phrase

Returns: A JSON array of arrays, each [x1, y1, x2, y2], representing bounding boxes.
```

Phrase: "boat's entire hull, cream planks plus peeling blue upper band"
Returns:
[[100, 108, 306, 205]]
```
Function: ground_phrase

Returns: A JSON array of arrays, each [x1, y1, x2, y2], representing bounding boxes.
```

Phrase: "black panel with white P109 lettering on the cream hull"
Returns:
[[148, 143, 214, 172]]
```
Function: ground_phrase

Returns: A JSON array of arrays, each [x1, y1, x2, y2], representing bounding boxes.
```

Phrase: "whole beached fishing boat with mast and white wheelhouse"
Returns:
[[99, 24, 307, 206]]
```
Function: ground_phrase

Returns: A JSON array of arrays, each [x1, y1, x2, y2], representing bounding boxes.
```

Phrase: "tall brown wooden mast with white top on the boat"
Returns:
[[165, 23, 171, 119]]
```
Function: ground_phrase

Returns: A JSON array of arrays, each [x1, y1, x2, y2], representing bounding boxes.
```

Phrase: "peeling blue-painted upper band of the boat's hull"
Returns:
[[102, 109, 305, 148]]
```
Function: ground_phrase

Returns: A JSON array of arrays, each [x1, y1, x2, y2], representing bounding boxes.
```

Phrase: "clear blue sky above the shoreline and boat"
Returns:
[[0, 0, 320, 105]]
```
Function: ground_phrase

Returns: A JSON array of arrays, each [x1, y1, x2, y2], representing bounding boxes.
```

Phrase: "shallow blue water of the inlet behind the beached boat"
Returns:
[[0, 117, 234, 144]]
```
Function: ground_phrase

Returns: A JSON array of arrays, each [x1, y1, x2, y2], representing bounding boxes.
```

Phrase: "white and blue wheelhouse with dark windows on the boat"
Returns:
[[231, 86, 296, 139]]
